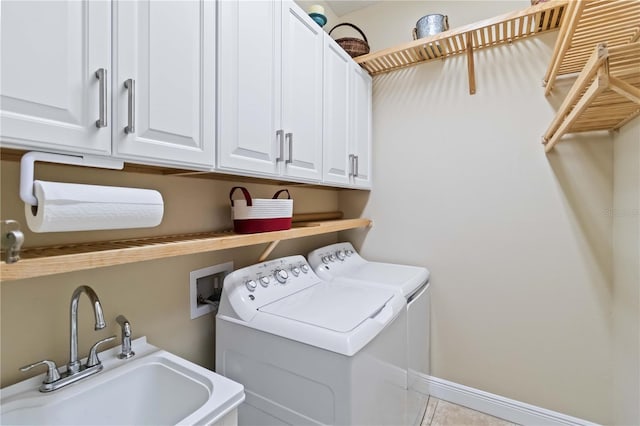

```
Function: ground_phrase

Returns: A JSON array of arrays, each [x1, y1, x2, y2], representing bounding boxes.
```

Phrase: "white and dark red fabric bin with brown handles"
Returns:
[[229, 186, 293, 234]]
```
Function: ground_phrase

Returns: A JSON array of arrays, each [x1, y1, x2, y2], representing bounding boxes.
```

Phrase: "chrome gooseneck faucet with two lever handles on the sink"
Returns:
[[20, 285, 116, 392]]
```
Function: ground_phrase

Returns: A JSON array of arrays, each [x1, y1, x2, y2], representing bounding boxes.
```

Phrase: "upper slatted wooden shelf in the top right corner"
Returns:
[[544, 0, 640, 95]]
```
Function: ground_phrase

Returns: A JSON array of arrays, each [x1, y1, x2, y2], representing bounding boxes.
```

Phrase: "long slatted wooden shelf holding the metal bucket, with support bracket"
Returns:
[[354, 0, 567, 93]]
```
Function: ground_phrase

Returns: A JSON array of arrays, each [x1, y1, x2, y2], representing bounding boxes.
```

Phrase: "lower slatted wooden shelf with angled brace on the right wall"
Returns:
[[542, 42, 640, 152]]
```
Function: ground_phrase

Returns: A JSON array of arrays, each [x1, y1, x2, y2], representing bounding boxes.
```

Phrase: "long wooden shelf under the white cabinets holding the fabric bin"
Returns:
[[0, 219, 372, 281]]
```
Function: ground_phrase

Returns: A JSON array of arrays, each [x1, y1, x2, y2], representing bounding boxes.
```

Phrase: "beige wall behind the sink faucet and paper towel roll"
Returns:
[[0, 161, 338, 387]]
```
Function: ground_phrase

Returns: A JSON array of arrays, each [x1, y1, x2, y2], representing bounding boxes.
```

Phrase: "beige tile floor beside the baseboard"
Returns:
[[422, 396, 517, 426]]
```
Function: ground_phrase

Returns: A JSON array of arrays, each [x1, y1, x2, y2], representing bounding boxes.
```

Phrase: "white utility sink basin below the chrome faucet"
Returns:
[[0, 338, 244, 425]]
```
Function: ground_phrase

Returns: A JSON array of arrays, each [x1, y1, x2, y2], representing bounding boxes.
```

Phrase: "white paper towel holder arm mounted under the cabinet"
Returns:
[[20, 151, 124, 207]]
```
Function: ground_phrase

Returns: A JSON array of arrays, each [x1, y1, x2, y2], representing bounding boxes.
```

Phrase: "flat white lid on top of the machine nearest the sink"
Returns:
[[258, 281, 393, 333]]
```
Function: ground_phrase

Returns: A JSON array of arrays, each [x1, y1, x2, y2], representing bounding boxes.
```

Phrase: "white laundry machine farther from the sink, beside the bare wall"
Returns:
[[307, 242, 431, 425]]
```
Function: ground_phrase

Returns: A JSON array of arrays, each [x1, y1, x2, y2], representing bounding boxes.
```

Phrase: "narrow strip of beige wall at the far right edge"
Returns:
[[612, 118, 640, 425]]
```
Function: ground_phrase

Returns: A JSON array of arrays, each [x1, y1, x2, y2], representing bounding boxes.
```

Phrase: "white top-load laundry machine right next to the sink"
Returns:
[[216, 256, 406, 426]]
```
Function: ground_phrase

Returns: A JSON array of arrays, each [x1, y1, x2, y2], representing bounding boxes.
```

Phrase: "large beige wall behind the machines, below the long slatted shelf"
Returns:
[[340, 1, 613, 423]]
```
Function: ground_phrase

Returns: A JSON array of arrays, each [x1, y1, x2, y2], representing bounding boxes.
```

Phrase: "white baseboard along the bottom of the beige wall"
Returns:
[[416, 375, 596, 426]]
